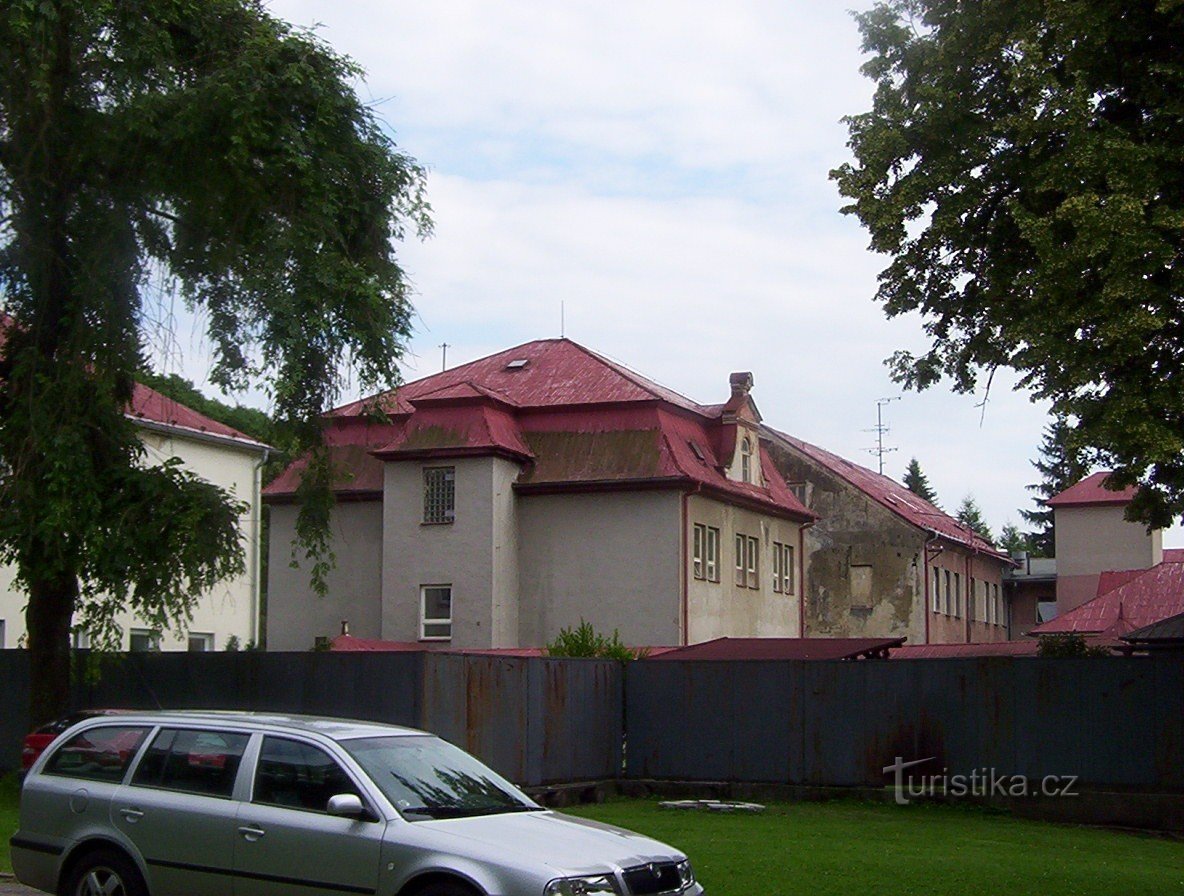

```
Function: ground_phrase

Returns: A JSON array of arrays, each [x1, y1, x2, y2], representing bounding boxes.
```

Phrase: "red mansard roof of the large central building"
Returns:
[[264, 340, 813, 520]]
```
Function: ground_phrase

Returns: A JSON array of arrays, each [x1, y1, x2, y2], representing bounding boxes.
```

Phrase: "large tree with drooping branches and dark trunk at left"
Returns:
[[0, 0, 427, 722]]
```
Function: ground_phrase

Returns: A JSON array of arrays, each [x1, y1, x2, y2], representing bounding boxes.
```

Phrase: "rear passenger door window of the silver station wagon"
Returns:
[[131, 728, 250, 798]]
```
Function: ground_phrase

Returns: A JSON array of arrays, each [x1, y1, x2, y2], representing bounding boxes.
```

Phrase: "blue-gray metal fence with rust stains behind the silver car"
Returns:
[[0, 651, 1184, 792]]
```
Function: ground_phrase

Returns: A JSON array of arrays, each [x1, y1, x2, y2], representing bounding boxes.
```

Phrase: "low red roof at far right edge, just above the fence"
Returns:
[[1031, 562, 1184, 638]]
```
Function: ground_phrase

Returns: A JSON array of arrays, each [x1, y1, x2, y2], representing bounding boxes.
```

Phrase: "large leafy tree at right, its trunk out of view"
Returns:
[[832, 0, 1184, 526]]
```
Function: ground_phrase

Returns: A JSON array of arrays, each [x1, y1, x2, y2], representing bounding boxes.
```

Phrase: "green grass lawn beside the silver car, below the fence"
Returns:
[[565, 800, 1184, 896]]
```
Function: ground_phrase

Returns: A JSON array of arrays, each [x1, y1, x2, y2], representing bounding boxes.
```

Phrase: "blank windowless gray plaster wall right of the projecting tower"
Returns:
[[517, 490, 682, 646]]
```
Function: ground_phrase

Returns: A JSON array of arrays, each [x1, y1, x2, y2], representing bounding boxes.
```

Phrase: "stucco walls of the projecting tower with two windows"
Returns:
[[382, 457, 519, 647]]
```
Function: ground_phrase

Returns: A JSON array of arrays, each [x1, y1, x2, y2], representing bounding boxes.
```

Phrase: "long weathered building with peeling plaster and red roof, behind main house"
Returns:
[[764, 427, 1010, 645]]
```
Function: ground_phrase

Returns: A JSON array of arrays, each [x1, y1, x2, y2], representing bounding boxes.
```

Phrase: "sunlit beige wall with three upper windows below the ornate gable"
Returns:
[[683, 492, 803, 644]]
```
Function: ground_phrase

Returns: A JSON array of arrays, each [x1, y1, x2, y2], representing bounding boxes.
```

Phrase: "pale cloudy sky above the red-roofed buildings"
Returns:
[[157, 0, 1184, 543]]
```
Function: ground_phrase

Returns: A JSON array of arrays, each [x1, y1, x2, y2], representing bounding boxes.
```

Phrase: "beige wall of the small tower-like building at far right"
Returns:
[[1055, 505, 1164, 613]]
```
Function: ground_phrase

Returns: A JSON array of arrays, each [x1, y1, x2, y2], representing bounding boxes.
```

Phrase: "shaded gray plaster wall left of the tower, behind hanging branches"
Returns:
[[268, 499, 382, 650]]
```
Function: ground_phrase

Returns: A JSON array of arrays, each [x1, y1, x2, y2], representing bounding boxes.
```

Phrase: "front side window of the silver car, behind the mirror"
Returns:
[[258, 737, 365, 812]]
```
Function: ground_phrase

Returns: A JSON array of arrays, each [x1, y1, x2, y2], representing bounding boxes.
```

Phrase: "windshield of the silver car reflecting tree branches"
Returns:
[[342, 735, 541, 821]]
